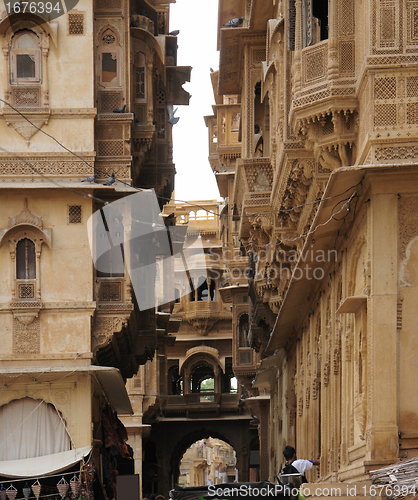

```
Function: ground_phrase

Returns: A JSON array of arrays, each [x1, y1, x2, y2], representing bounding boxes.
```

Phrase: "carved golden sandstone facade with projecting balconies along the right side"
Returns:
[[212, 0, 418, 488]]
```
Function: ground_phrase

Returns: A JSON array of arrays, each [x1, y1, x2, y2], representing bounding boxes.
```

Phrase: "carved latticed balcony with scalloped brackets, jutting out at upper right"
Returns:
[[289, 40, 358, 171]]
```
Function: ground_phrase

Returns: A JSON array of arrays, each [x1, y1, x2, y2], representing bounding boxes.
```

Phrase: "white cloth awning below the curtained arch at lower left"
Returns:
[[0, 446, 92, 478]]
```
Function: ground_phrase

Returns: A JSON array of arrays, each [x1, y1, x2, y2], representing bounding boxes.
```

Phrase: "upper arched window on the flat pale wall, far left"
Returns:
[[10, 30, 42, 83]]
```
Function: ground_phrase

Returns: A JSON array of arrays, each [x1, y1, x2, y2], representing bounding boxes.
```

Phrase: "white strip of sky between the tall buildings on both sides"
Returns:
[[170, 0, 220, 200]]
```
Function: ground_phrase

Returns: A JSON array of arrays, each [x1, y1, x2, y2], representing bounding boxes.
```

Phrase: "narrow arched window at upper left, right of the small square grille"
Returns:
[[98, 28, 122, 87]]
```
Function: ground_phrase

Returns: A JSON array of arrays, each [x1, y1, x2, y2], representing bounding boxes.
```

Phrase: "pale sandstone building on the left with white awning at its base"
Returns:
[[0, 0, 190, 498]]
